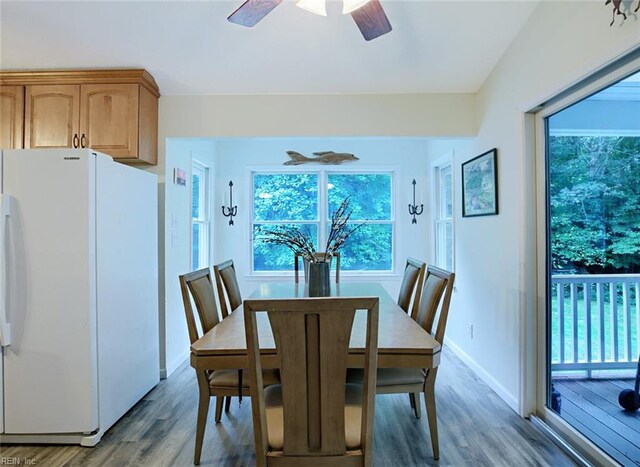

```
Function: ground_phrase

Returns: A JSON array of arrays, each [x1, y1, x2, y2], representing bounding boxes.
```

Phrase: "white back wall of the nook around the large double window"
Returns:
[[214, 138, 444, 297]]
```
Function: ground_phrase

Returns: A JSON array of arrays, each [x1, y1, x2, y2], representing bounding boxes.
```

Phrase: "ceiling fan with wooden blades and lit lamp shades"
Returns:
[[227, 0, 392, 41]]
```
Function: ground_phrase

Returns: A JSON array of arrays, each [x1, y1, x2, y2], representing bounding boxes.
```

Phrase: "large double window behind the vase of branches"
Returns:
[[251, 171, 395, 272]]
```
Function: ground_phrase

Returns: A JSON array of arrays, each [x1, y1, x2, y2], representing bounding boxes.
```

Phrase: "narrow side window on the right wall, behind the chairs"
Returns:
[[434, 162, 453, 271]]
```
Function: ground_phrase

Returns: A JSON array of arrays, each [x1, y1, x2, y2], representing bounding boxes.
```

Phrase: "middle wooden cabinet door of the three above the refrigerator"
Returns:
[[24, 85, 80, 149]]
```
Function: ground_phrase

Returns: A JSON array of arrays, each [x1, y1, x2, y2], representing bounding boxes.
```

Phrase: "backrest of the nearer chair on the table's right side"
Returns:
[[416, 266, 455, 344]]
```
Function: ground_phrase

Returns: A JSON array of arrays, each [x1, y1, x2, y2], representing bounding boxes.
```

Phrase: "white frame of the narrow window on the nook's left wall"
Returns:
[[190, 159, 211, 270]]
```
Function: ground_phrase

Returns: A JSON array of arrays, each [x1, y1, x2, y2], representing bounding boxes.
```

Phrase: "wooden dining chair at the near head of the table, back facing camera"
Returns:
[[244, 297, 379, 467]]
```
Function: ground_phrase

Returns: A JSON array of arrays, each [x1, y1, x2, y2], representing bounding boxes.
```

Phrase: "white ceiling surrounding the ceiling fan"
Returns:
[[0, 0, 537, 95]]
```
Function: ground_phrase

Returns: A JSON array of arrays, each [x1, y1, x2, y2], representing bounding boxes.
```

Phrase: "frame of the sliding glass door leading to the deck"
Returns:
[[523, 52, 640, 465]]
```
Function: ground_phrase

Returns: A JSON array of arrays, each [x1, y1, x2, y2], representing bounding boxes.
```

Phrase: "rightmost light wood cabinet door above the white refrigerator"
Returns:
[[80, 84, 139, 159]]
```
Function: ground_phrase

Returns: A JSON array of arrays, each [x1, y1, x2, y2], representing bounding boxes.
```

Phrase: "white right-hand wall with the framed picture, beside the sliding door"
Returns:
[[447, 2, 640, 410]]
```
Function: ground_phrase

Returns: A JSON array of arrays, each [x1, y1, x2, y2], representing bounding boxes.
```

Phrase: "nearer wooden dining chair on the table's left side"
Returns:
[[179, 268, 279, 465]]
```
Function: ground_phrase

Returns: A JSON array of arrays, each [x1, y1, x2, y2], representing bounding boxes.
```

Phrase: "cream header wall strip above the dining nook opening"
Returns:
[[158, 94, 477, 166]]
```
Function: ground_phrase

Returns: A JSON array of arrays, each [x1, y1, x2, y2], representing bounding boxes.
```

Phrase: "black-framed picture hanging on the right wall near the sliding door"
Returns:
[[462, 148, 498, 217]]
